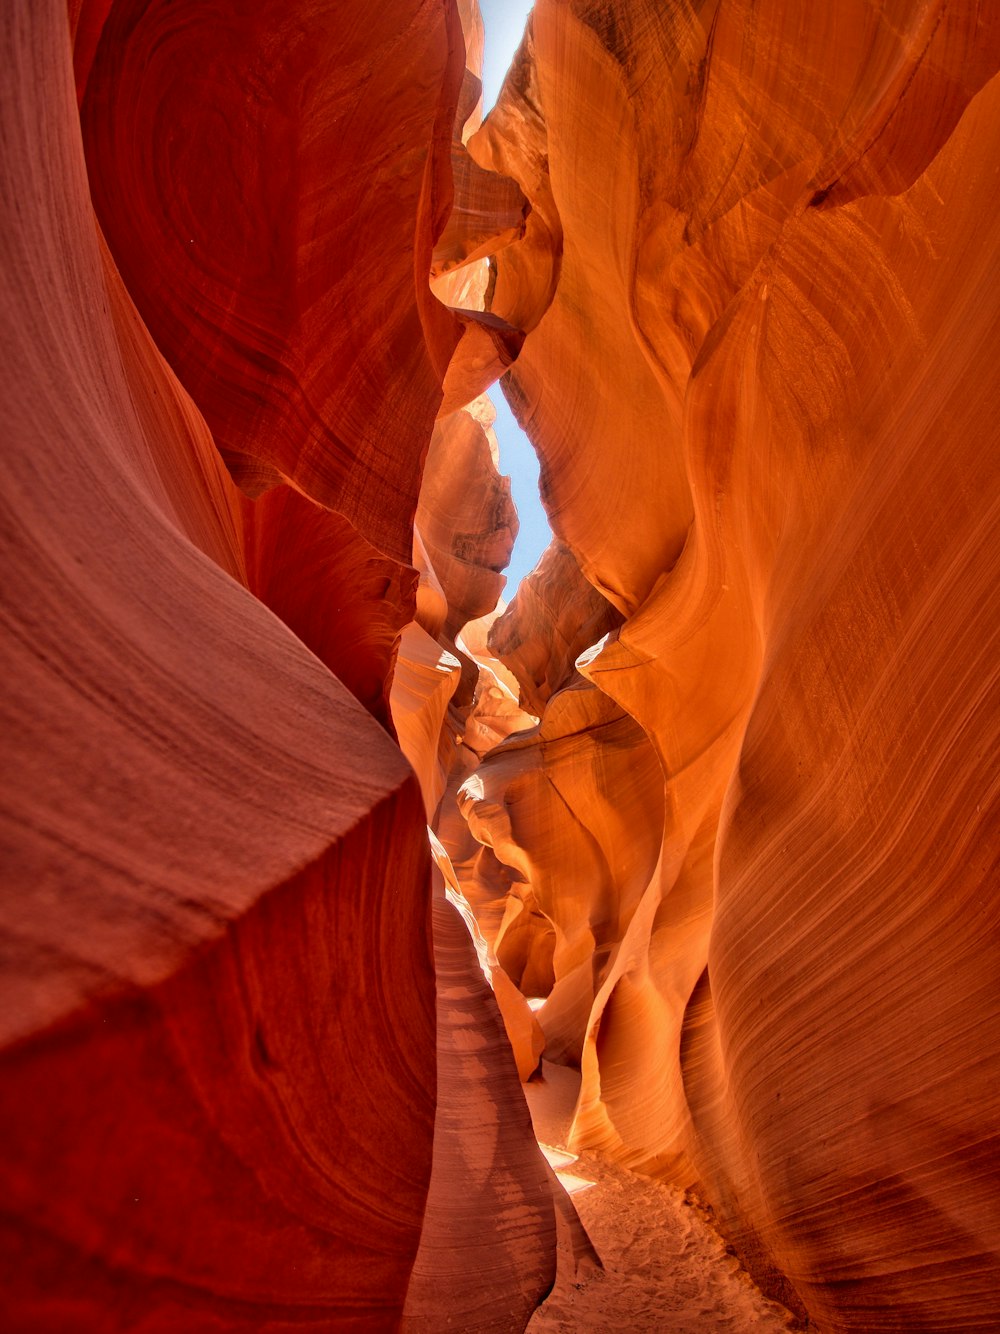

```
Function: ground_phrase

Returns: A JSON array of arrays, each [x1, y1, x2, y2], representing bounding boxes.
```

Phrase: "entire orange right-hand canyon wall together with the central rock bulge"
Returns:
[[456, 0, 1000, 1331]]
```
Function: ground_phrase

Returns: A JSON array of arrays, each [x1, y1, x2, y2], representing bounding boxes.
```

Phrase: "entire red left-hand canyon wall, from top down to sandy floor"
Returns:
[[0, 0, 556, 1334]]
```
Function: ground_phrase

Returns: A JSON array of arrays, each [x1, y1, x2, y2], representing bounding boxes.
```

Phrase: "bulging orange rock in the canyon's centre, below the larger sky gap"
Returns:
[[459, 686, 663, 1093]]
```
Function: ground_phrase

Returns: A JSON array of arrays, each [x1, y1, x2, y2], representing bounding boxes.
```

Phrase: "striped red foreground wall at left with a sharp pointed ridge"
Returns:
[[0, 5, 435, 1330]]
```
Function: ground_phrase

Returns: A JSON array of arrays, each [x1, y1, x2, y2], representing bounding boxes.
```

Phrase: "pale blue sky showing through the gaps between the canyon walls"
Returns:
[[480, 0, 552, 602]]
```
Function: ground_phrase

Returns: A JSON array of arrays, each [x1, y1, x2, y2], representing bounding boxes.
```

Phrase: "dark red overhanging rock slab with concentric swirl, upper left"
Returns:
[[81, 0, 464, 562]]
